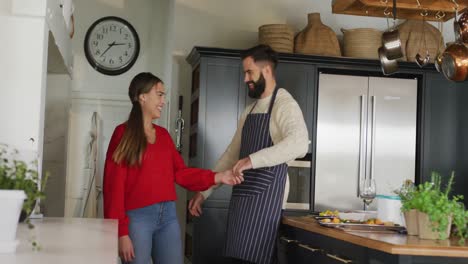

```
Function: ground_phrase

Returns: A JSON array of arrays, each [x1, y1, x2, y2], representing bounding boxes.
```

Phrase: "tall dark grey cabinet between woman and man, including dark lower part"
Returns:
[[186, 56, 245, 264]]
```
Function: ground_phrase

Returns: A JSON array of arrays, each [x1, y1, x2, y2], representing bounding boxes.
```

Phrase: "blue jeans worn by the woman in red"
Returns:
[[127, 201, 183, 264]]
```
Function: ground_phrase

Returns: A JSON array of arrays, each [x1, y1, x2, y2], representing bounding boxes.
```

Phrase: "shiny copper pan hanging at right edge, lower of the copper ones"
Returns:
[[442, 42, 468, 82]]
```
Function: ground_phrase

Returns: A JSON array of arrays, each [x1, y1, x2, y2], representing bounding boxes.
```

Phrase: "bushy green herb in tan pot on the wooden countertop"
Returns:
[[400, 172, 468, 244]]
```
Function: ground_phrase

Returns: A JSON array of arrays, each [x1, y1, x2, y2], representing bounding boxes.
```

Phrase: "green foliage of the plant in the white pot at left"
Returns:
[[0, 143, 49, 250]]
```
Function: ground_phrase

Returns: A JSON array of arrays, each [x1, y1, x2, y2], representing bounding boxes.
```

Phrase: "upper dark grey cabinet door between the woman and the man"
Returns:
[[189, 57, 245, 200]]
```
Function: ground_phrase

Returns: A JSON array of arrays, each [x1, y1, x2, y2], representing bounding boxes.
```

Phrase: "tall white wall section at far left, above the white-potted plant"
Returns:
[[0, 16, 48, 163]]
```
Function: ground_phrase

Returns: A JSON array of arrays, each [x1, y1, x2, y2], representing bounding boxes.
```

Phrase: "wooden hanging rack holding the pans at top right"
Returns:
[[332, 0, 468, 21]]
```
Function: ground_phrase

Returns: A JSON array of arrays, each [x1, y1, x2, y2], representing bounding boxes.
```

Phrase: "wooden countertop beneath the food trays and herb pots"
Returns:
[[283, 216, 468, 262]]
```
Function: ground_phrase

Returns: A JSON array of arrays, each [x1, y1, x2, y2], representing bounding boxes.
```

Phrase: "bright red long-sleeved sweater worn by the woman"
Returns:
[[103, 124, 214, 237]]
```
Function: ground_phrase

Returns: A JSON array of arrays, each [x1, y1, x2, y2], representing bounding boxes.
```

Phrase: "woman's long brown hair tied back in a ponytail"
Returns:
[[112, 72, 162, 166]]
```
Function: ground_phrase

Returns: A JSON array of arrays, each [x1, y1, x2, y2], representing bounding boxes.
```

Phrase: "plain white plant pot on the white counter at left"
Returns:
[[0, 190, 26, 253]]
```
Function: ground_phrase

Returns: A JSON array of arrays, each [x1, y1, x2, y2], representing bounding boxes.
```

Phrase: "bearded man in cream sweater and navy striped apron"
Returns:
[[189, 45, 309, 264]]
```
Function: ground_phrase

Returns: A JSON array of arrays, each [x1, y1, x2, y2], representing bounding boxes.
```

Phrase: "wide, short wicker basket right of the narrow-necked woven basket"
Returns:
[[341, 28, 382, 59]]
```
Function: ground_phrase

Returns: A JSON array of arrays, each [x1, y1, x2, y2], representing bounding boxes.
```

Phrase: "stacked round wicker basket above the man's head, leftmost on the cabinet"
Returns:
[[258, 24, 294, 53]]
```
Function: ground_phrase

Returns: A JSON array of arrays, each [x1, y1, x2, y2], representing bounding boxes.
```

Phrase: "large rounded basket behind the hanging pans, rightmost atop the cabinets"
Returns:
[[398, 20, 444, 62]]
